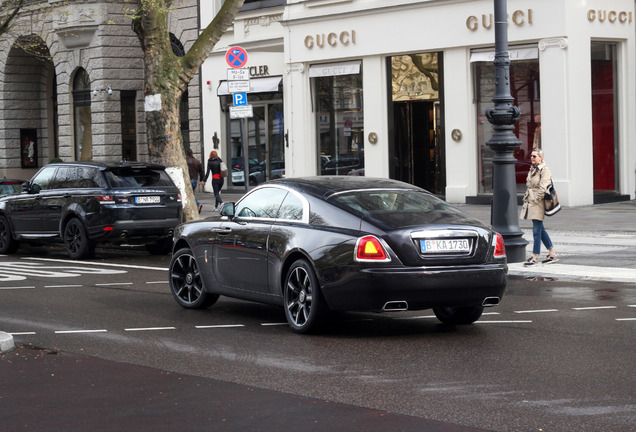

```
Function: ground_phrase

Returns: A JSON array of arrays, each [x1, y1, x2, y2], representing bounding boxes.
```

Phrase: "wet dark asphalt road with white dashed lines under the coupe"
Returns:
[[0, 248, 636, 432]]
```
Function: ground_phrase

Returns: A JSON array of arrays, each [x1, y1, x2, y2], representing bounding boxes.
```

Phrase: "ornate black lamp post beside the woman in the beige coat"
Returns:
[[486, 0, 528, 263]]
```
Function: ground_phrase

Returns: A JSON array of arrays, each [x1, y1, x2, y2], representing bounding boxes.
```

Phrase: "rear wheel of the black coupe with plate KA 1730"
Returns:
[[283, 259, 328, 333]]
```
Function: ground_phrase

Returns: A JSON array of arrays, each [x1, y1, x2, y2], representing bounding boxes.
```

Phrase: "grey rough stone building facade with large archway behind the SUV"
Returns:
[[0, 0, 201, 179]]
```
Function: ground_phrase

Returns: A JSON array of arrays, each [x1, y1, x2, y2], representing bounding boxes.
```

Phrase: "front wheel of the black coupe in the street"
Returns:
[[168, 248, 219, 309]]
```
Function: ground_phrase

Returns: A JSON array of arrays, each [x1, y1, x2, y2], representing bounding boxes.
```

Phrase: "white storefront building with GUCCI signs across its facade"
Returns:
[[203, 0, 636, 206]]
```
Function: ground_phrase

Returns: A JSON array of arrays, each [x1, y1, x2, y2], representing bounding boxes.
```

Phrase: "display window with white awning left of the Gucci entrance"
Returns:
[[309, 62, 364, 175]]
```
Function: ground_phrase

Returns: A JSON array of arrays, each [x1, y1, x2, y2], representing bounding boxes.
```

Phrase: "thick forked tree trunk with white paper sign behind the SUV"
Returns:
[[132, 0, 245, 220]]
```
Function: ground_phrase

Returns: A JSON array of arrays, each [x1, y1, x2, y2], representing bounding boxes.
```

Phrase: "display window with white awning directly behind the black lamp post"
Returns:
[[471, 48, 541, 194]]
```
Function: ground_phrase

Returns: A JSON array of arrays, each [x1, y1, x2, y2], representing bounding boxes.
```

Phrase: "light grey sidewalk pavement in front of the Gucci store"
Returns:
[[197, 189, 636, 283]]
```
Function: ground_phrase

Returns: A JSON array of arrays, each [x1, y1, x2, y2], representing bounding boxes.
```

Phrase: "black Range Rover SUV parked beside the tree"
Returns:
[[0, 162, 182, 259]]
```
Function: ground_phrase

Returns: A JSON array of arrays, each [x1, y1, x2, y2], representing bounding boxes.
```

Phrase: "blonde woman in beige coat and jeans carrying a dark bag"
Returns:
[[521, 149, 557, 266]]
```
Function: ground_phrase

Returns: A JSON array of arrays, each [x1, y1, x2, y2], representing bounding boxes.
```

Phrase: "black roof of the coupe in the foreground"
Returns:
[[269, 176, 426, 199]]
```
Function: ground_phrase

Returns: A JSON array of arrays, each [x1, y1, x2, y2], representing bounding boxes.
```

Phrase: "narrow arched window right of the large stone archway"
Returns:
[[73, 68, 93, 160]]
